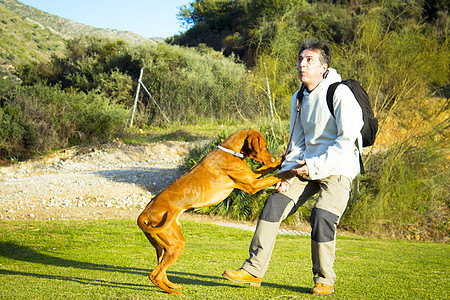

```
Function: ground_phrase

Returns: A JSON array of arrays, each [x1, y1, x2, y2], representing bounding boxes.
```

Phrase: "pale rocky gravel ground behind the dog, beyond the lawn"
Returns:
[[0, 142, 309, 234]]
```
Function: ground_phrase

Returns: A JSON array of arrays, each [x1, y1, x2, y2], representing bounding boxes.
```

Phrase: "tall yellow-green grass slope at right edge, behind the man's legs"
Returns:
[[342, 104, 450, 240]]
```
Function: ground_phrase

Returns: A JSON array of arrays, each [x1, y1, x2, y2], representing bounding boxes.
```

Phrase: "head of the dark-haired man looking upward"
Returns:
[[297, 39, 331, 91]]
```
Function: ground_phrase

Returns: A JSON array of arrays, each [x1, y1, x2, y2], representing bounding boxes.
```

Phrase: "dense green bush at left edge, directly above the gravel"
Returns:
[[0, 84, 130, 159]]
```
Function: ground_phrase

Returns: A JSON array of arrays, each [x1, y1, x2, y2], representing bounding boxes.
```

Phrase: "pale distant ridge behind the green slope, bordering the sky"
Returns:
[[0, 0, 159, 44]]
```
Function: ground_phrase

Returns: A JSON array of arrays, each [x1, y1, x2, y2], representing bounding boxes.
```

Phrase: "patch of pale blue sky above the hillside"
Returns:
[[19, 0, 194, 38]]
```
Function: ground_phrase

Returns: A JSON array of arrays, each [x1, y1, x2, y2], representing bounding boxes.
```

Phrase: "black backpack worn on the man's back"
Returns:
[[327, 79, 378, 174]]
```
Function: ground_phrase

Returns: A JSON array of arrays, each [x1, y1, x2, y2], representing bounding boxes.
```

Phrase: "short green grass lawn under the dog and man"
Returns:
[[0, 220, 450, 299]]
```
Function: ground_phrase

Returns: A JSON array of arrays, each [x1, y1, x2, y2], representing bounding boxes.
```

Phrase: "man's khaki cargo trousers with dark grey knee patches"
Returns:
[[242, 176, 352, 286]]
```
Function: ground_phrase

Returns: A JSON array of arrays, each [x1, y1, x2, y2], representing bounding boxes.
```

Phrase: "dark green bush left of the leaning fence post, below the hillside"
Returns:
[[17, 36, 139, 104]]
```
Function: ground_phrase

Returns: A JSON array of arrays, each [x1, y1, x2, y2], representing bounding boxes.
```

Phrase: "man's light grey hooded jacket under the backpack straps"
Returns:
[[280, 68, 364, 180]]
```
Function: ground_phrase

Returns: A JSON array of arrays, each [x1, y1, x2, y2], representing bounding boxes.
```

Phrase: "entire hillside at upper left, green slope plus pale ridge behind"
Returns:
[[0, 0, 161, 86]]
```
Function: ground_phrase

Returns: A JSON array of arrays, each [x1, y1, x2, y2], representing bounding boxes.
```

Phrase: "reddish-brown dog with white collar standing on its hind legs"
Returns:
[[138, 129, 292, 294]]
